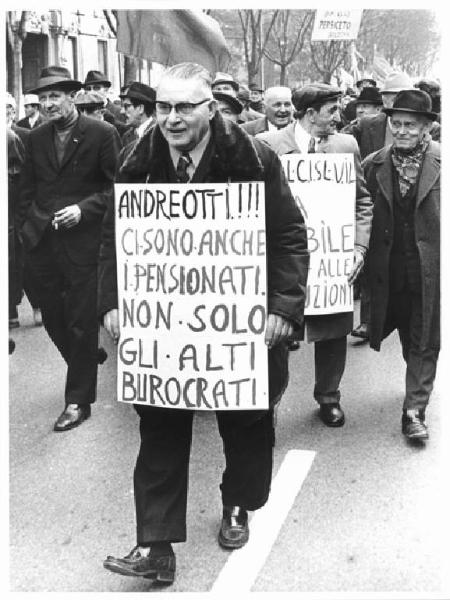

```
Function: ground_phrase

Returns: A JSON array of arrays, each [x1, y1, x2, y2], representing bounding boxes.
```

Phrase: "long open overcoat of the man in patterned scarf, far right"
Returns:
[[363, 142, 441, 350]]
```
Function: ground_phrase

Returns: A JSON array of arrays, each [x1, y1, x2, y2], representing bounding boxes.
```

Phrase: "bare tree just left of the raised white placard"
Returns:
[[263, 10, 314, 85]]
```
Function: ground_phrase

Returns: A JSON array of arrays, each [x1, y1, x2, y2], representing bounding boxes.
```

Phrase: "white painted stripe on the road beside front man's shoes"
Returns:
[[211, 450, 315, 592]]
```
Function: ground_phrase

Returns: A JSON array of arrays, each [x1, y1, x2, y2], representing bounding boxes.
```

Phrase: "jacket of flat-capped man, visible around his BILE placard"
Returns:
[[256, 123, 372, 341]]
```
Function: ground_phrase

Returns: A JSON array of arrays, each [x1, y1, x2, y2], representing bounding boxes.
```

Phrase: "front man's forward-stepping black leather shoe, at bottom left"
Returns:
[[103, 546, 176, 585]]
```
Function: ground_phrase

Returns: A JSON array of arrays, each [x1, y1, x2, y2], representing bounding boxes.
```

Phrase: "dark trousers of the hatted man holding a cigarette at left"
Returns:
[[27, 230, 98, 404]]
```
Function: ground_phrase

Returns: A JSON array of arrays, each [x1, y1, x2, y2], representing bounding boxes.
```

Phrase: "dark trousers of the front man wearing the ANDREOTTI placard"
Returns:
[[134, 405, 273, 544]]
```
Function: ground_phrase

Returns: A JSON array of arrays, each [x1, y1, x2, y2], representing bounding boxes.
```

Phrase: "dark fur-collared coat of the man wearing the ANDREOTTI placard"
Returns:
[[98, 113, 309, 402]]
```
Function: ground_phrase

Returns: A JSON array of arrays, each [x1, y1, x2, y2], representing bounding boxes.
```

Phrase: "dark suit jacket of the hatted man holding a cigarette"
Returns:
[[20, 115, 120, 264]]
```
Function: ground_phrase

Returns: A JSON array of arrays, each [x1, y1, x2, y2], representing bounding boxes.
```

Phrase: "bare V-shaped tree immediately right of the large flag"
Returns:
[[238, 10, 278, 85]]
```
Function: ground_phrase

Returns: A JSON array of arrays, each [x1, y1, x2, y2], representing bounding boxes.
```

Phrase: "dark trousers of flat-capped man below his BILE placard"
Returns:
[[314, 335, 347, 404]]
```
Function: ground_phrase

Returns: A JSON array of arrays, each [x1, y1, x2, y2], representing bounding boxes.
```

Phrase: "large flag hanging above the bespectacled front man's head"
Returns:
[[117, 9, 231, 73]]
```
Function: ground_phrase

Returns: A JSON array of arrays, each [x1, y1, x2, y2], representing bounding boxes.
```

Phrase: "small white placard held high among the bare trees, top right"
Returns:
[[311, 9, 362, 42]]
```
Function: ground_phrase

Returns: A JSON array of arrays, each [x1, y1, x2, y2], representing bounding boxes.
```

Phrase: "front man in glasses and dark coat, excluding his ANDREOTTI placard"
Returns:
[[99, 63, 309, 583]]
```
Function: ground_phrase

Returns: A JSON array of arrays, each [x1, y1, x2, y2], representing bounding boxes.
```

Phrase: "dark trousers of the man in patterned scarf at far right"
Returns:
[[383, 289, 439, 410]]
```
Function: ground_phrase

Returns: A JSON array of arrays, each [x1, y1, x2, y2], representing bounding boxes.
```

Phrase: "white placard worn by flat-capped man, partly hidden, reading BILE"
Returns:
[[280, 153, 356, 315]]
